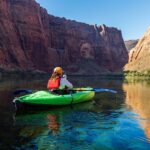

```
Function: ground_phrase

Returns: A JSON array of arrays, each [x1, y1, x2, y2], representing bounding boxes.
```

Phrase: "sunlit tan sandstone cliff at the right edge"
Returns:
[[125, 29, 150, 72]]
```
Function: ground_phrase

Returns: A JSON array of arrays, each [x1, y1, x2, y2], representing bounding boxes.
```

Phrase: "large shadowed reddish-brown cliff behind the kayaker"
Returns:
[[0, 0, 128, 74]]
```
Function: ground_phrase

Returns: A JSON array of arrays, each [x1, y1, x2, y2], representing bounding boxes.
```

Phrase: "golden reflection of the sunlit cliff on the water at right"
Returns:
[[123, 83, 150, 139]]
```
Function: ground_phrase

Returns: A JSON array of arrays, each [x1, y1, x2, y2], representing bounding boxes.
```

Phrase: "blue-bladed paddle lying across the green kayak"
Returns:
[[13, 88, 117, 95]]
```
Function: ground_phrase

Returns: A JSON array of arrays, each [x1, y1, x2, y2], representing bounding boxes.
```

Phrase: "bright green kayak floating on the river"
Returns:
[[14, 88, 95, 106]]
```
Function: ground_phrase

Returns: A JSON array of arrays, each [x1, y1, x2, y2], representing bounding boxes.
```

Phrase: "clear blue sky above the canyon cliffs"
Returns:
[[36, 0, 150, 40]]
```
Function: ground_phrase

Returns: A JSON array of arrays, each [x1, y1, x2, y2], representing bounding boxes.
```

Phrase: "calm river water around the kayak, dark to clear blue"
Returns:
[[0, 77, 150, 150]]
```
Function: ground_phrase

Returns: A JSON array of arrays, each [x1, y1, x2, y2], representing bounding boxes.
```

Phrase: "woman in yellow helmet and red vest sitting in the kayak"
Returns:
[[47, 67, 73, 94]]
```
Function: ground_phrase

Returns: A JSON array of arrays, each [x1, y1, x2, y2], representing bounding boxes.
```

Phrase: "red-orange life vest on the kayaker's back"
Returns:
[[47, 78, 61, 90]]
